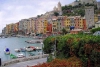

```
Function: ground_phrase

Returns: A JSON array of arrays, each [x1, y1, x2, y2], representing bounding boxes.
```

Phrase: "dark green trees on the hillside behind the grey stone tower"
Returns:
[[62, 3, 99, 16]]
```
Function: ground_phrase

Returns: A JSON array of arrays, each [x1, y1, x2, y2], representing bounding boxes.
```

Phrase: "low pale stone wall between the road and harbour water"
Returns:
[[2, 54, 49, 66]]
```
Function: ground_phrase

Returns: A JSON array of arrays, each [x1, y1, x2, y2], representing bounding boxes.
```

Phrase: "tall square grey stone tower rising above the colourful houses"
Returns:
[[85, 6, 95, 29]]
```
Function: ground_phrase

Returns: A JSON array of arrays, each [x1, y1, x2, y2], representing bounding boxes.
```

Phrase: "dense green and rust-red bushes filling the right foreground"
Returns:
[[33, 34, 100, 67]]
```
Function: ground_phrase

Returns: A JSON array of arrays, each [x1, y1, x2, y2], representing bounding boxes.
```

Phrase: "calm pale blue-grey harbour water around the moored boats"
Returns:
[[0, 37, 42, 61]]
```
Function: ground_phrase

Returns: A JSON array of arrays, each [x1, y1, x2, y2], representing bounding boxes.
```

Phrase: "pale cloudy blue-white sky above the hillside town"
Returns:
[[0, 0, 99, 33]]
